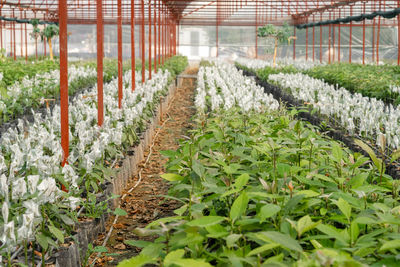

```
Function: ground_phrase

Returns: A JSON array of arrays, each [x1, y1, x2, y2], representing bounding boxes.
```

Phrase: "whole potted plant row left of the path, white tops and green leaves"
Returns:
[[0, 56, 188, 264]]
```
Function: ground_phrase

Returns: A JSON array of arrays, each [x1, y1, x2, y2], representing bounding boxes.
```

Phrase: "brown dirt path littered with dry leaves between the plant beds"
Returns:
[[90, 69, 197, 266]]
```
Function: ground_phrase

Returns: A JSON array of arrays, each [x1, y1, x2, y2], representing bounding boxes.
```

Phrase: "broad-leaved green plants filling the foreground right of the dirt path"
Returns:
[[119, 106, 400, 267]]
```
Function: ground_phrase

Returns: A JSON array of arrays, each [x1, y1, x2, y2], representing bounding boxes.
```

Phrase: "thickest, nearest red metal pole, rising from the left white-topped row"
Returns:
[[58, 1, 69, 170]]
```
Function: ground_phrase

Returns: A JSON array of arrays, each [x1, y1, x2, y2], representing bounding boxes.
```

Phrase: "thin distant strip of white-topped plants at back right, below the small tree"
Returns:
[[236, 58, 326, 70]]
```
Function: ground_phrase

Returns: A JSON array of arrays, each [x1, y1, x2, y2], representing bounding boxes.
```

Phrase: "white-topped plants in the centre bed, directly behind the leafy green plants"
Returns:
[[195, 63, 279, 111]]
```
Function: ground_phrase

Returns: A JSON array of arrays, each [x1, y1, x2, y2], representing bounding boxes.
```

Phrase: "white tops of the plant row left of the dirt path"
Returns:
[[0, 68, 170, 260]]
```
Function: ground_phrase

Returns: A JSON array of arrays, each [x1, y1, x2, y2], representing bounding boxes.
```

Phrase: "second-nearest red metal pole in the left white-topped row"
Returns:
[[96, 0, 104, 127]]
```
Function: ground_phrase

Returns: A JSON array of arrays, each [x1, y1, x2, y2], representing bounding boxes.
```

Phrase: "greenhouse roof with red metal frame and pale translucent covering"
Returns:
[[0, 0, 399, 26]]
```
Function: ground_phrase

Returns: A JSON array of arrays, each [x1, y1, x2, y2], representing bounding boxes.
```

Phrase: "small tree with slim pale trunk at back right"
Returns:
[[257, 23, 296, 67]]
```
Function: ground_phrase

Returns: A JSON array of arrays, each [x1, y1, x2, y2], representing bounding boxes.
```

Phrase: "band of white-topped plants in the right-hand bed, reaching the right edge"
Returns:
[[269, 73, 400, 149]]
